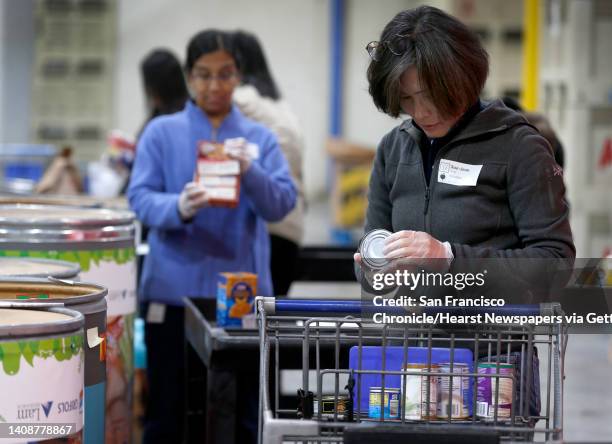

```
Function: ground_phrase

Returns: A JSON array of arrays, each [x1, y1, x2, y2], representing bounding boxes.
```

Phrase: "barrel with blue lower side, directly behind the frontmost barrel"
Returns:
[[0, 277, 107, 442]]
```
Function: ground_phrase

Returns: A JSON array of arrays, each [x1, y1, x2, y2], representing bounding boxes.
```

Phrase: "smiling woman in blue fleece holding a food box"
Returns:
[[128, 30, 296, 443]]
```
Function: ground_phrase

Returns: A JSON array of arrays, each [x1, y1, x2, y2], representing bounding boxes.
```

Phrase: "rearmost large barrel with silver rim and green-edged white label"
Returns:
[[0, 204, 136, 444]]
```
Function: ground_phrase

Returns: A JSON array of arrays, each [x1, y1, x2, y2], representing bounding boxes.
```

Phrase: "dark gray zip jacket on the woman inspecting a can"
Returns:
[[366, 100, 575, 259]]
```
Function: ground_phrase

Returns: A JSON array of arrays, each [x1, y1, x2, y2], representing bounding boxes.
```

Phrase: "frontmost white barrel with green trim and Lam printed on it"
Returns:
[[0, 301, 85, 444]]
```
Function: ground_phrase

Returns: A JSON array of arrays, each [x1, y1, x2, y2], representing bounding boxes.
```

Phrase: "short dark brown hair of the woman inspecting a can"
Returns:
[[367, 6, 489, 123]]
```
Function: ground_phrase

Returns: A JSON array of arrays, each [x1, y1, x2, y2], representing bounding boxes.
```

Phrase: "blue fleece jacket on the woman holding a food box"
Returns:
[[128, 101, 296, 305]]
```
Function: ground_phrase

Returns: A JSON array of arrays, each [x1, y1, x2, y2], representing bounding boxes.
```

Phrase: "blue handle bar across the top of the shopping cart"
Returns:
[[258, 297, 559, 316]]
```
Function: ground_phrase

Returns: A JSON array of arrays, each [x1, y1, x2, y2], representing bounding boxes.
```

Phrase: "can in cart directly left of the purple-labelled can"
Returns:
[[437, 363, 471, 419]]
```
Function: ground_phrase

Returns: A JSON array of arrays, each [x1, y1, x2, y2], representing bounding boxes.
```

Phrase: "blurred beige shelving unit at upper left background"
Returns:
[[31, 0, 116, 162]]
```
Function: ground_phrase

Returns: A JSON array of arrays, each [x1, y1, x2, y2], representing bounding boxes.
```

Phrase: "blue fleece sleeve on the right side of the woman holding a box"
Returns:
[[241, 133, 296, 222]]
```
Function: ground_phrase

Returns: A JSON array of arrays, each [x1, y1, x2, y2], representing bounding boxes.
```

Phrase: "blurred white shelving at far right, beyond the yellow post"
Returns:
[[540, 0, 612, 257]]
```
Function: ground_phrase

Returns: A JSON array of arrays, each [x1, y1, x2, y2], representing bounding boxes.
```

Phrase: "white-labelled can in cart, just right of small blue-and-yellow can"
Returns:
[[402, 364, 438, 419]]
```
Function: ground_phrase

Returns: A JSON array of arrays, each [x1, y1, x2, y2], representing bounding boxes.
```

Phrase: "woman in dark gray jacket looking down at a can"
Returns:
[[355, 6, 575, 426]]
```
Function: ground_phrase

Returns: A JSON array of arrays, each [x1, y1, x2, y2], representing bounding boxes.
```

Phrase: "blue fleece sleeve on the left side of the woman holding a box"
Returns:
[[127, 122, 184, 229]]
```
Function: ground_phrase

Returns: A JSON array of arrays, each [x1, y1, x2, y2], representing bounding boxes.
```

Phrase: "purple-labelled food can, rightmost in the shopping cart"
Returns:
[[476, 362, 514, 420]]
